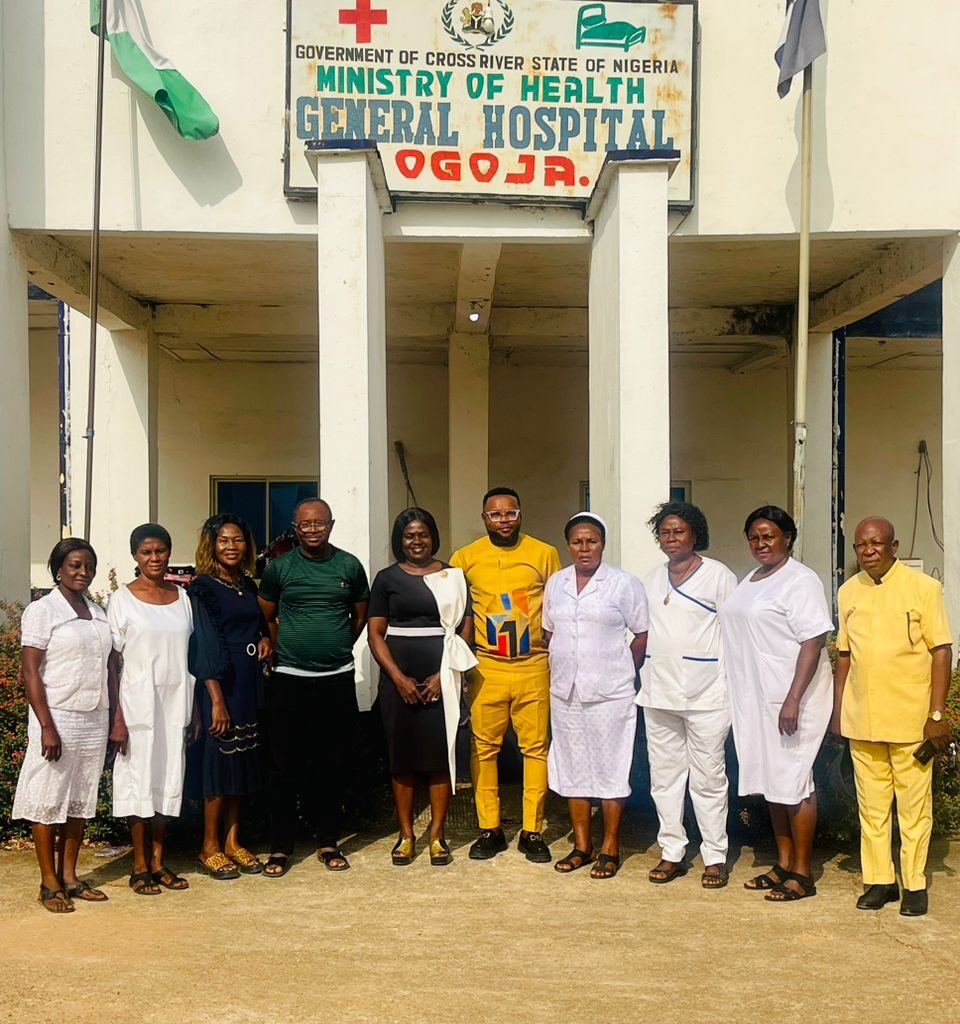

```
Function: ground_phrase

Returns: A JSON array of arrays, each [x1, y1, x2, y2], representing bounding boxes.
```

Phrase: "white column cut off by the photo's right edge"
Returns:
[[943, 234, 960, 638]]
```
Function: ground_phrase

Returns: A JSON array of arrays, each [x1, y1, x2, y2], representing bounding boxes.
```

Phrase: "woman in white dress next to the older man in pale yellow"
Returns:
[[721, 505, 833, 902]]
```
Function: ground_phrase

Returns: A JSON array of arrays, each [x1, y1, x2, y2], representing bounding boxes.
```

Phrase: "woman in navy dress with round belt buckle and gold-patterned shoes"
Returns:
[[188, 513, 271, 879]]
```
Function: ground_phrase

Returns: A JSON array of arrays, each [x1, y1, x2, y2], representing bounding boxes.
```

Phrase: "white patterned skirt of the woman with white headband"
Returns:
[[548, 693, 637, 800]]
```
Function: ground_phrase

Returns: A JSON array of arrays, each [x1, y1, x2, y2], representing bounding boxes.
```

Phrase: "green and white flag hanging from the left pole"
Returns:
[[90, 0, 220, 139]]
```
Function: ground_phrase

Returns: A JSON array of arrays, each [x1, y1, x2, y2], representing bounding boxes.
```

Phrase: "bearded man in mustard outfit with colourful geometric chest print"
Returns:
[[450, 487, 560, 863]]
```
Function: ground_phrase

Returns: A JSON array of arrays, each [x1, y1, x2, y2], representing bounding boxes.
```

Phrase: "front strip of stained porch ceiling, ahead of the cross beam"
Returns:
[[50, 233, 890, 306]]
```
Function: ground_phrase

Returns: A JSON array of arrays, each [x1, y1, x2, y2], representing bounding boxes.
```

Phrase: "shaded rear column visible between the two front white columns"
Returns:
[[444, 334, 490, 551]]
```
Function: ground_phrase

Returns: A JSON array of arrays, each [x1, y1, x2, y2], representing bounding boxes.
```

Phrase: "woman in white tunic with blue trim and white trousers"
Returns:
[[637, 502, 737, 889]]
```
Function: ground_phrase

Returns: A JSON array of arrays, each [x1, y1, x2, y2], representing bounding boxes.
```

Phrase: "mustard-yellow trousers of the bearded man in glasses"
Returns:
[[467, 657, 550, 831]]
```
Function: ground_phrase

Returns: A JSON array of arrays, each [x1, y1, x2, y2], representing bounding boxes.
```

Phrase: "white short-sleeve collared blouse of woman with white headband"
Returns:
[[543, 562, 648, 703]]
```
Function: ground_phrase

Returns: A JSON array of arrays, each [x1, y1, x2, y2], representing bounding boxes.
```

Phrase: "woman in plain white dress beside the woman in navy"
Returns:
[[106, 522, 193, 896]]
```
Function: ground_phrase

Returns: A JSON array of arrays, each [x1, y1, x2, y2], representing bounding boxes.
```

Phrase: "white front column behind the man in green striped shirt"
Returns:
[[313, 153, 392, 710]]
